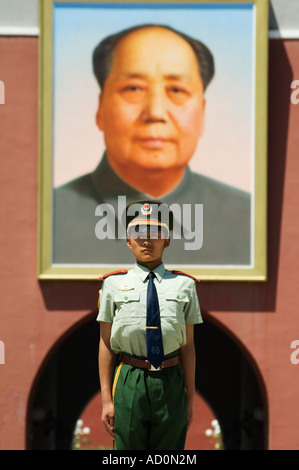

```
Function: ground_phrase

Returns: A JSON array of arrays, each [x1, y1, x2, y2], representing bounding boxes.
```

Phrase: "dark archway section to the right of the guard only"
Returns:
[[195, 313, 268, 450]]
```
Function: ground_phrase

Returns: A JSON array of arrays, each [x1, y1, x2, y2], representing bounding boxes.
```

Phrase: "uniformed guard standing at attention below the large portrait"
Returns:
[[97, 201, 202, 450]]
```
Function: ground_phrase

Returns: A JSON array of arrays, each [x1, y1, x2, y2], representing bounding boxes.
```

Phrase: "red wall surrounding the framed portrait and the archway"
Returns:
[[0, 37, 299, 449]]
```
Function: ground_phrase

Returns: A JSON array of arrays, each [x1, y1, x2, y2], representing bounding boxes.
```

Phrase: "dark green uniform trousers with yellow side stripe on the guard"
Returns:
[[112, 363, 187, 450]]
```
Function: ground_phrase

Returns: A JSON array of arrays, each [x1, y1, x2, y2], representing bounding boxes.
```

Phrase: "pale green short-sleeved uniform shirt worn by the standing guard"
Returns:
[[97, 263, 203, 357]]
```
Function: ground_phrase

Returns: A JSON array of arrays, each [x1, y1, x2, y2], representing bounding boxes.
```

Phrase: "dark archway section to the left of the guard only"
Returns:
[[26, 313, 100, 450]]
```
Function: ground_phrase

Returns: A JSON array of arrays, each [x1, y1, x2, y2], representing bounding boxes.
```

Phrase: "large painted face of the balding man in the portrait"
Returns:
[[97, 28, 205, 171]]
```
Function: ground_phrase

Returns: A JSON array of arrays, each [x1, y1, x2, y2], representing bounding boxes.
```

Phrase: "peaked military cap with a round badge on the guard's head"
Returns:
[[124, 200, 173, 237]]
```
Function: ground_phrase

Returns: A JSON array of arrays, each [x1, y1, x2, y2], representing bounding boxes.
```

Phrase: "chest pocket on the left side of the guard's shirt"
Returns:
[[114, 292, 140, 325]]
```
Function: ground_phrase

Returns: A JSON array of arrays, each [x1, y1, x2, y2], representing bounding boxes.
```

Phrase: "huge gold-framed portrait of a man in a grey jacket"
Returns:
[[39, 1, 267, 280]]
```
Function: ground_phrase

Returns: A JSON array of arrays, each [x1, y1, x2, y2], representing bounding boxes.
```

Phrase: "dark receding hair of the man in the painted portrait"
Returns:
[[92, 24, 215, 90]]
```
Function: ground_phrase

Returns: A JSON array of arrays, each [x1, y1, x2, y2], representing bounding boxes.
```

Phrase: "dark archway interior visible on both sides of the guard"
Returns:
[[27, 313, 267, 450]]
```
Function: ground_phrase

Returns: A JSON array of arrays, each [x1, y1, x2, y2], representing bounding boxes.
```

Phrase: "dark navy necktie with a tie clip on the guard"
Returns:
[[146, 271, 164, 369]]
